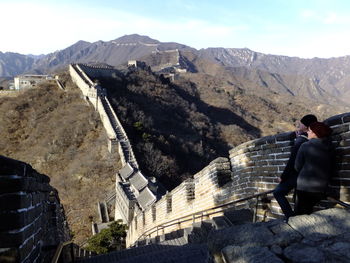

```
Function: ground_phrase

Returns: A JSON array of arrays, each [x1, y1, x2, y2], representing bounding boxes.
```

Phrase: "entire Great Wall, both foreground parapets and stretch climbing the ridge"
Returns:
[[0, 64, 350, 262]]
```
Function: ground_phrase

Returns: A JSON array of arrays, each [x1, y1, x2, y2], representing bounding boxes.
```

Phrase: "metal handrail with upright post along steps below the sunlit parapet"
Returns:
[[137, 190, 273, 241]]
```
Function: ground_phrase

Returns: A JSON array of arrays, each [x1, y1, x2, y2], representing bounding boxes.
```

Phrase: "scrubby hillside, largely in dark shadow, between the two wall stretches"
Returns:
[[88, 68, 336, 190]]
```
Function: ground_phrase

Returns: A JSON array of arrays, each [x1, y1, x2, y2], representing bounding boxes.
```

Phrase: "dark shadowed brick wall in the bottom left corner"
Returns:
[[0, 156, 69, 262]]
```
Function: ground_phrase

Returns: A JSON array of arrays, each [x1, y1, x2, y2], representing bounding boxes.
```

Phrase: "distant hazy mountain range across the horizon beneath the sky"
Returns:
[[0, 34, 350, 106]]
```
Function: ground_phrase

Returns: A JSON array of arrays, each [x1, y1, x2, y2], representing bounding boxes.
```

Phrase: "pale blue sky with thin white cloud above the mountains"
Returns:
[[0, 0, 350, 58]]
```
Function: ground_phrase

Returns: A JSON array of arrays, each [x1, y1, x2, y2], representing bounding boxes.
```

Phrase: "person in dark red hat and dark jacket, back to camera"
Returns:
[[294, 122, 332, 215]]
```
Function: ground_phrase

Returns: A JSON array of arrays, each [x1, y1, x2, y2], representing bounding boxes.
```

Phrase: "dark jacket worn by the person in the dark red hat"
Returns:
[[295, 138, 332, 193]]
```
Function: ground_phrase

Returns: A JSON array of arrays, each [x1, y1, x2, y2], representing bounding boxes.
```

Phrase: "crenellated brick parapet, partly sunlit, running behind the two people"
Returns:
[[127, 113, 350, 248]]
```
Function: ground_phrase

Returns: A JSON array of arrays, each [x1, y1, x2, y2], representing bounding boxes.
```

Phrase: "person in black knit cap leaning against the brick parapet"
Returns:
[[273, 114, 317, 221]]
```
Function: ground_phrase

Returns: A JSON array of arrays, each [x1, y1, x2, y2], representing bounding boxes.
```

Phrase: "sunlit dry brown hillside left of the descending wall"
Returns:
[[0, 72, 120, 243]]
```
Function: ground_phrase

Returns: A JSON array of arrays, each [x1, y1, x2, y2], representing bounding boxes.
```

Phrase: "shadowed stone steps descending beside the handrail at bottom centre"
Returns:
[[79, 209, 253, 263]]
